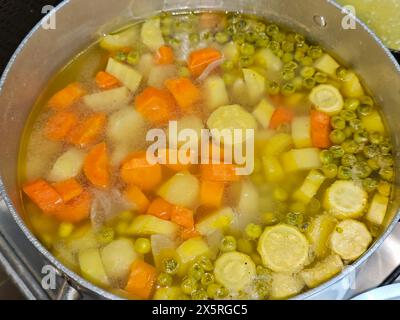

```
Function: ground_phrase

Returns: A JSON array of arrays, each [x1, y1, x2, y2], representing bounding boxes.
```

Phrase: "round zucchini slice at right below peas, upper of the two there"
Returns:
[[324, 180, 368, 219]]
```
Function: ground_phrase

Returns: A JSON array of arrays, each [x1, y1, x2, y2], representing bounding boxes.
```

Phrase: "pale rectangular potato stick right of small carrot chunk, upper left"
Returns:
[[106, 58, 142, 93]]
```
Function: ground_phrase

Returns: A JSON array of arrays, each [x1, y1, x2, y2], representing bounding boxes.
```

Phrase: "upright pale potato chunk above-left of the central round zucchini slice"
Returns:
[[203, 76, 229, 111]]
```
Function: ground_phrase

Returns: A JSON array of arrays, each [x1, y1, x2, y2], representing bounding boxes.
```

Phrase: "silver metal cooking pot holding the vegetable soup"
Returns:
[[0, 0, 400, 299]]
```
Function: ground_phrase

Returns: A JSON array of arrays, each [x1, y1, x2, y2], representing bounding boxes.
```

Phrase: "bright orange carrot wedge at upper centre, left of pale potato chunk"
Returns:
[[165, 78, 200, 112]]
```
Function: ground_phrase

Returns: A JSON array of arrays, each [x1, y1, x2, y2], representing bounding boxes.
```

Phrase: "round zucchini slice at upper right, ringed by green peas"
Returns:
[[309, 84, 344, 116]]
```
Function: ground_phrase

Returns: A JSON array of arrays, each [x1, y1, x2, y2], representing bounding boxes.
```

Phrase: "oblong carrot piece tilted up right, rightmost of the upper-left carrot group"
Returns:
[[68, 113, 107, 147]]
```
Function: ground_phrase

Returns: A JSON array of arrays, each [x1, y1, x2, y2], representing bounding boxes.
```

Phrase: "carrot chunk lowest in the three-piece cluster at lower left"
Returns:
[[54, 191, 92, 223]]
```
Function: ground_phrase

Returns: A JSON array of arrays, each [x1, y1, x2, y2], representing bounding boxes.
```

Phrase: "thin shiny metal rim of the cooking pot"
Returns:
[[0, 0, 400, 300]]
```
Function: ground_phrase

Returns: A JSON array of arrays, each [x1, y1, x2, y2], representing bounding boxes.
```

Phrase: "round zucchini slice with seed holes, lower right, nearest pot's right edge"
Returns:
[[330, 219, 372, 260]]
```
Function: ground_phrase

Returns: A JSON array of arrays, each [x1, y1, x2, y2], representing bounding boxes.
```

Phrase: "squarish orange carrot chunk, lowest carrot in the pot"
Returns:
[[125, 259, 157, 299]]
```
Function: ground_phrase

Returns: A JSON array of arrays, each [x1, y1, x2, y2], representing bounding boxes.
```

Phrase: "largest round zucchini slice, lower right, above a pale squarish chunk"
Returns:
[[257, 224, 310, 273]]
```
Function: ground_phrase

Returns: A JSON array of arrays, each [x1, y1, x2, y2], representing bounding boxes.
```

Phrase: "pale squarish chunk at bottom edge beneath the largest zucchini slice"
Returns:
[[270, 273, 304, 300]]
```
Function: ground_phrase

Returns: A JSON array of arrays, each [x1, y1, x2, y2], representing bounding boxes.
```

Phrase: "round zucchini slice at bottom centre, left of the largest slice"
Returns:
[[214, 252, 256, 292]]
